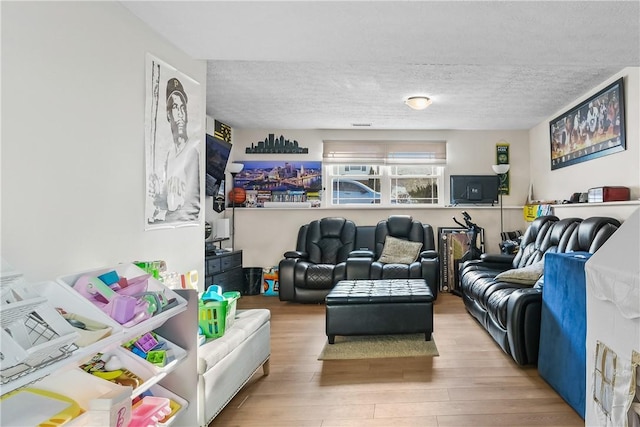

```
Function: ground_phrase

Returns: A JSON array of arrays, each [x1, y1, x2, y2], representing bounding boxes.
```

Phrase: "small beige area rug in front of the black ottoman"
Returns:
[[318, 334, 438, 360]]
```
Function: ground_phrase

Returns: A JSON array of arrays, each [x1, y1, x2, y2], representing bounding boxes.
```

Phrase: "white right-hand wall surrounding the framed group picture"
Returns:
[[529, 67, 640, 205]]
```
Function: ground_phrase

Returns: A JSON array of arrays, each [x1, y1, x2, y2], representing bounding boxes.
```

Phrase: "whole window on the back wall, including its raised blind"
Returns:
[[323, 141, 446, 206]]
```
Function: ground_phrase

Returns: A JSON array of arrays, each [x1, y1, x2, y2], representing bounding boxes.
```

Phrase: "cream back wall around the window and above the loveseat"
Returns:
[[229, 129, 529, 267]]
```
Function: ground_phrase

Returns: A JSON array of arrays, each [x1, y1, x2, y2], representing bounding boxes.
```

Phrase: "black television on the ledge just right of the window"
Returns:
[[449, 175, 500, 206]]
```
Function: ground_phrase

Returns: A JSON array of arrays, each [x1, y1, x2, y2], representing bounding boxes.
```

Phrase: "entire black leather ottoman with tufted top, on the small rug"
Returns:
[[325, 279, 433, 344]]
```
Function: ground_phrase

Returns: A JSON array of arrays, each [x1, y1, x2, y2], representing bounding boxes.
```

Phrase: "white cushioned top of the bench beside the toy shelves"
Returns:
[[198, 308, 271, 374]]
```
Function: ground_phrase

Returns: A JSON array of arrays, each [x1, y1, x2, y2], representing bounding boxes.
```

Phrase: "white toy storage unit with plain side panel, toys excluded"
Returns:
[[0, 264, 198, 426]]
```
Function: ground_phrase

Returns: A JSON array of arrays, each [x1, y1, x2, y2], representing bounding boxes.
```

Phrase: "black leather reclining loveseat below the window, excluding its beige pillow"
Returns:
[[279, 215, 439, 303]]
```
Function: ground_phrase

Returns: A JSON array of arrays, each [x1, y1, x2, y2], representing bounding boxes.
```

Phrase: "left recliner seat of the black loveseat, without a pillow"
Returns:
[[278, 217, 356, 303]]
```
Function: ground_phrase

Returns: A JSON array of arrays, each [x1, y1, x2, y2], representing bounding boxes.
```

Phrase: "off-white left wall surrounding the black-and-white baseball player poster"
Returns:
[[1, 2, 206, 280]]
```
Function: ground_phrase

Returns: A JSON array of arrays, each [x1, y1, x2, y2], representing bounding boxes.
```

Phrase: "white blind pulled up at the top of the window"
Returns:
[[322, 141, 447, 165]]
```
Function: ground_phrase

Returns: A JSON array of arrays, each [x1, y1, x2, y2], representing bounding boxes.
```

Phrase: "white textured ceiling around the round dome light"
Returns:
[[122, 0, 640, 129]]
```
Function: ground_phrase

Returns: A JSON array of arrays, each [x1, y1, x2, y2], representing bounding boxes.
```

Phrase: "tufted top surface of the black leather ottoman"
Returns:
[[325, 279, 433, 305]]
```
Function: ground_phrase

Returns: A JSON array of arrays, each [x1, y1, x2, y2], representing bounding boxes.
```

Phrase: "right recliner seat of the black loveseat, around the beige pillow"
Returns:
[[347, 215, 440, 299]]
